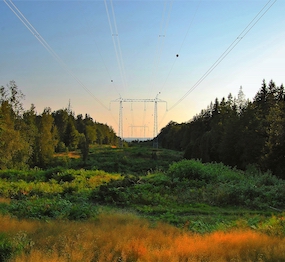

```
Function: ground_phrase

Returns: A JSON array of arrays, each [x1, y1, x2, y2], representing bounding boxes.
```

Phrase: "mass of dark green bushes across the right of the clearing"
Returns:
[[90, 160, 285, 211]]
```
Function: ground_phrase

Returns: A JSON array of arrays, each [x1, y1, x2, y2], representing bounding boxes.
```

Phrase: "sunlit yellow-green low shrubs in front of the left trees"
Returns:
[[0, 167, 121, 200]]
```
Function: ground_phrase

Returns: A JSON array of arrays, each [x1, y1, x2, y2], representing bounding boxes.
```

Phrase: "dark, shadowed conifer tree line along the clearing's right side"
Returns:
[[158, 80, 285, 178]]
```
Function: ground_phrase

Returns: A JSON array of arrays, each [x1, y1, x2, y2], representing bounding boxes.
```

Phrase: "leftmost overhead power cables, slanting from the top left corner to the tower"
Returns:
[[3, 0, 108, 110]]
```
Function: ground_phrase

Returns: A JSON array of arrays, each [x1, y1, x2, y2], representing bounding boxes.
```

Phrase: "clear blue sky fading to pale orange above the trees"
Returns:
[[0, 0, 285, 137]]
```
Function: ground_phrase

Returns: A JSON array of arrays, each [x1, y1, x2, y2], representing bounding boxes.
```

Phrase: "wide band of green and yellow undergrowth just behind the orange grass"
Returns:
[[0, 149, 285, 235]]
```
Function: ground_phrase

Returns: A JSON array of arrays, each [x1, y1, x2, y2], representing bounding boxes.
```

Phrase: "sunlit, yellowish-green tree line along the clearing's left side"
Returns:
[[0, 81, 118, 169]]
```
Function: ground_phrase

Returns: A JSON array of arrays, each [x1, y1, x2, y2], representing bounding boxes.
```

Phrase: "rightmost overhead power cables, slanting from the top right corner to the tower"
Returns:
[[169, 0, 277, 110]]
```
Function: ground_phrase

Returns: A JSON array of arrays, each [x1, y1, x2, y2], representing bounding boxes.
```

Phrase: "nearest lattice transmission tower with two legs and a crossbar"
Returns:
[[111, 93, 167, 148]]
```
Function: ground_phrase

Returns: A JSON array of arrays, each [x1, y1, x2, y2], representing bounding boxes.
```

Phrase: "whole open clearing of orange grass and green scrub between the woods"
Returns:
[[0, 145, 285, 262]]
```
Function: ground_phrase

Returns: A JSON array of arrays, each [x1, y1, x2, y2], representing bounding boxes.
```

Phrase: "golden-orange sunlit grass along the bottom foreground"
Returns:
[[0, 214, 285, 262]]
